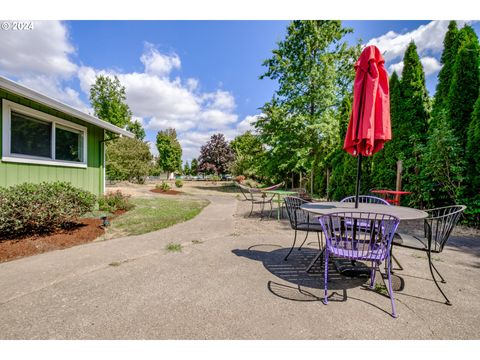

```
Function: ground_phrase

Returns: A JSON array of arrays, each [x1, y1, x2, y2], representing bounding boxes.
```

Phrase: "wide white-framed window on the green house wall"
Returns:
[[2, 100, 87, 167]]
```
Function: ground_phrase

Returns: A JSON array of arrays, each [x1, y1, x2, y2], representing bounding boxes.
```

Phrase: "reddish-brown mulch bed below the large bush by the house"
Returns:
[[0, 219, 105, 262]]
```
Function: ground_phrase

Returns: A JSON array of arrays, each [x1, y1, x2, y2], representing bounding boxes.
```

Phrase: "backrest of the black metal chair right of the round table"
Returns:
[[425, 205, 467, 252]]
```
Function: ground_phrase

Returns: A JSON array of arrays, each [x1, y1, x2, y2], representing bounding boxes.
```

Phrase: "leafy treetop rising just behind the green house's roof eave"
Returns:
[[90, 75, 132, 128]]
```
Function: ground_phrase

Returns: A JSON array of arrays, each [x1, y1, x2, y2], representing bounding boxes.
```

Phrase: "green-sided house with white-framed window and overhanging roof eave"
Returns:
[[0, 76, 133, 195]]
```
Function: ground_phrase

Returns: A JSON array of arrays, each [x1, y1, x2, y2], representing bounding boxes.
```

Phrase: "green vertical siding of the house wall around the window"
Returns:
[[0, 89, 104, 195]]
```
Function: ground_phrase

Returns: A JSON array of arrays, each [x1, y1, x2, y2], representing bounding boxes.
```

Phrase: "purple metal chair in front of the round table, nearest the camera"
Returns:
[[319, 211, 400, 317]]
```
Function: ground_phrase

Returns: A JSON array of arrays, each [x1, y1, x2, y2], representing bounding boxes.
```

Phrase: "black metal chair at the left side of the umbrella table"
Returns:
[[283, 196, 323, 260]]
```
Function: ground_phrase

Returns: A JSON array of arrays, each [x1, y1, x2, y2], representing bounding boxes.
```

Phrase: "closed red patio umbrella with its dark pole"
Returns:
[[343, 45, 392, 208]]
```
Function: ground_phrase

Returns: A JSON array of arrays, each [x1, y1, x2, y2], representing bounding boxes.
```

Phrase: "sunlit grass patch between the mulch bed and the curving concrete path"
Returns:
[[106, 197, 208, 239]]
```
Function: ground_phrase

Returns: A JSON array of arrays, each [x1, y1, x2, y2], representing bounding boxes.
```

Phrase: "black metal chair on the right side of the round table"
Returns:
[[390, 205, 467, 305]]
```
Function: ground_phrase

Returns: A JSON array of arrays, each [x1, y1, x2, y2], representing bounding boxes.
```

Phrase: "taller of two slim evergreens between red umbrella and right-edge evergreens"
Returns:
[[391, 41, 429, 206]]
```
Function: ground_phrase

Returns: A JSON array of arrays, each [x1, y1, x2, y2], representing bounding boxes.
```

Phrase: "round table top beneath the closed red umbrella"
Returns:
[[301, 202, 428, 220]]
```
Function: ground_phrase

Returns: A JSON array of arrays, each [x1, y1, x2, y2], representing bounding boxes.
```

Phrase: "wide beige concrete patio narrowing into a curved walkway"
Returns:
[[0, 190, 480, 339]]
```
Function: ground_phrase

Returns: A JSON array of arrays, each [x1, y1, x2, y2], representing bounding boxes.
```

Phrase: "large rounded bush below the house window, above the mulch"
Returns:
[[0, 182, 96, 238]]
